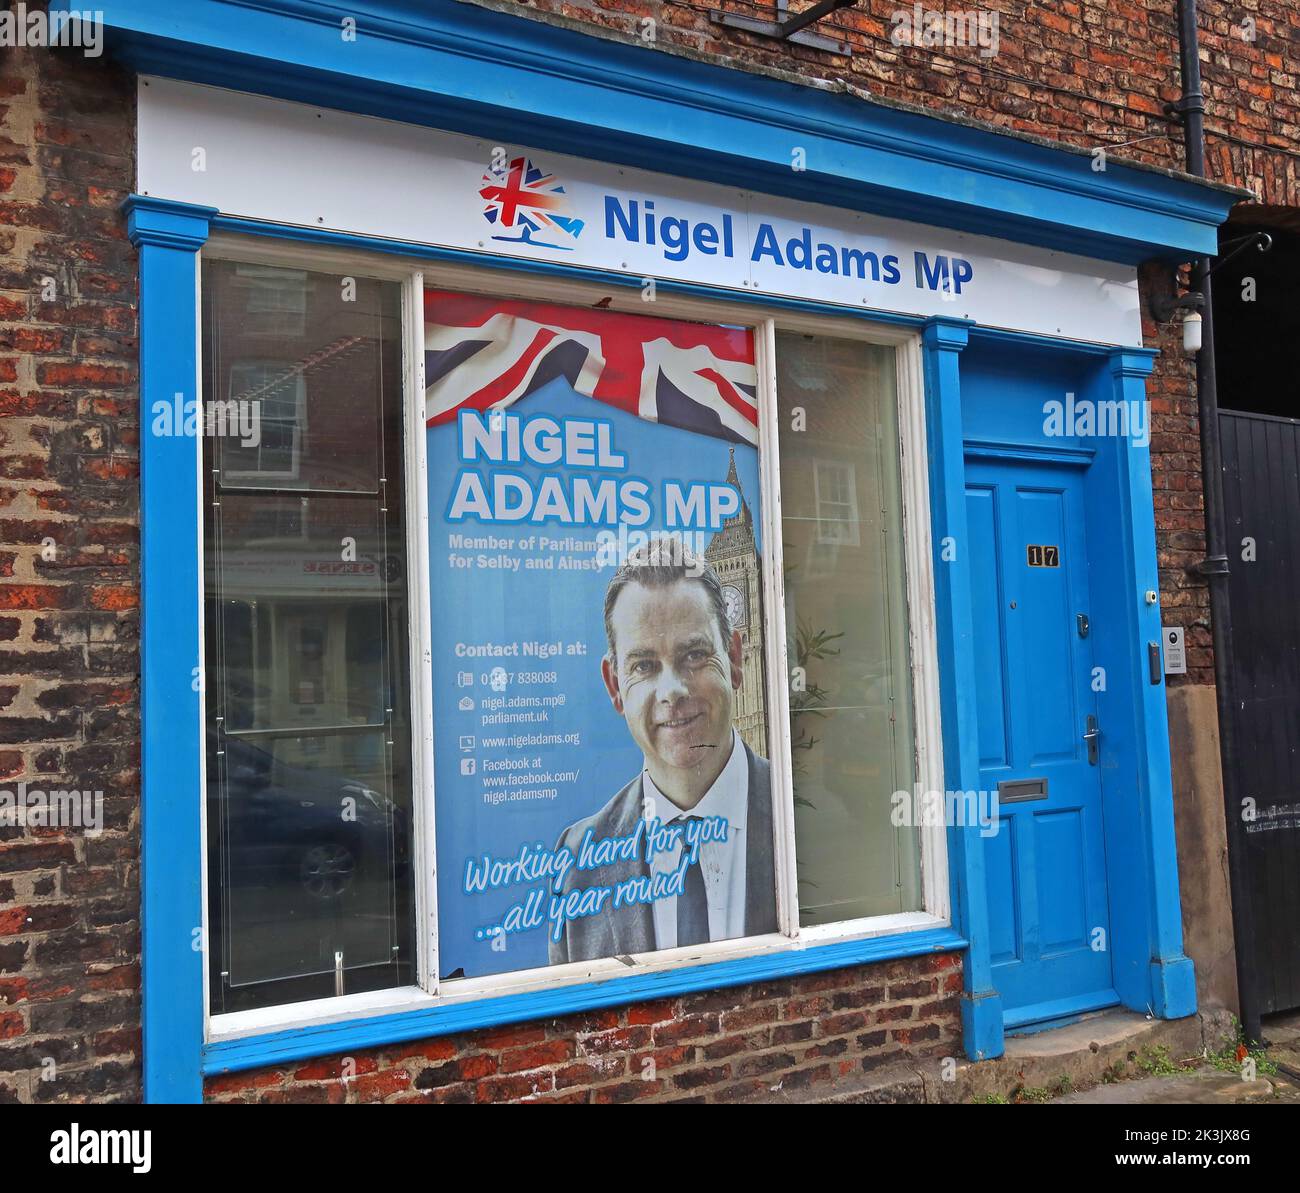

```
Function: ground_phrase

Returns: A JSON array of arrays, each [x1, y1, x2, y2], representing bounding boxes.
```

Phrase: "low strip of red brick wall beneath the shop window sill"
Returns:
[[204, 954, 962, 1103]]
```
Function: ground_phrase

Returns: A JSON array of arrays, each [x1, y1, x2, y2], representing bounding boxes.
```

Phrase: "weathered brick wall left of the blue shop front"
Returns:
[[0, 39, 139, 1102]]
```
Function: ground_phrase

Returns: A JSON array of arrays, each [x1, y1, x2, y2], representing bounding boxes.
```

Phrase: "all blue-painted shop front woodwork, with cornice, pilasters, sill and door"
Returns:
[[78, 0, 1232, 1101]]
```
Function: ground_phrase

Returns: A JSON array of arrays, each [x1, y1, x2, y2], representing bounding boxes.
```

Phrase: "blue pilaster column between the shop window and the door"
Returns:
[[922, 317, 1002, 1060]]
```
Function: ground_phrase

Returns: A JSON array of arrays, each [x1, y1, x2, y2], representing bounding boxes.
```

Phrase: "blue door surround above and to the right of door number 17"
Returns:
[[962, 331, 1196, 1023]]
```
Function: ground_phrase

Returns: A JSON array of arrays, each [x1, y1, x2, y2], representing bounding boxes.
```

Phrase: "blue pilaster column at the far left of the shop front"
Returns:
[[122, 195, 216, 1102]]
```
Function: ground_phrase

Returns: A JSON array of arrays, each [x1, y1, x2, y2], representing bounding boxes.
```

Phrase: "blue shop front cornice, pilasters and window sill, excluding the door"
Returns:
[[104, 0, 1236, 1102]]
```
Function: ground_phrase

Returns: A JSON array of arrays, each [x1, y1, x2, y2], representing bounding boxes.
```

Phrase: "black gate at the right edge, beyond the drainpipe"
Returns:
[[1219, 411, 1300, 1015]]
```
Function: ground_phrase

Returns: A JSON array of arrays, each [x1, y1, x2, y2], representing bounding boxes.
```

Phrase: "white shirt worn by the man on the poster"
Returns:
[[641, 729, 749, 949]]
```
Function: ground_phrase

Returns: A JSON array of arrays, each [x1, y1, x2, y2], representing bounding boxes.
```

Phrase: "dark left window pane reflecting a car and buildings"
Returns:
[[203, 261, 415, 1011]]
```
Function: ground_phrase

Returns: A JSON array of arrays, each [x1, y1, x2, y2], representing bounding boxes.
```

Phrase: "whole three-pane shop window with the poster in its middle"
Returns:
[[203, 260, 937, 1029]]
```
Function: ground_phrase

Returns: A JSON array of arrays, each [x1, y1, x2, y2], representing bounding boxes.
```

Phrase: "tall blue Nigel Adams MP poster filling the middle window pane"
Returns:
[[425, 290, 776, 980]]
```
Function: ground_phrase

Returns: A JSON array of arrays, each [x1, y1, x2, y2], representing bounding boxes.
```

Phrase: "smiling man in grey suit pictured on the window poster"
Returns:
[[550, 537, 776, 964]]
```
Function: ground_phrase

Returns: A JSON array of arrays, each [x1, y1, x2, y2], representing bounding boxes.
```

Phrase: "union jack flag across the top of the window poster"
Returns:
[[424, 290, 758, 446]]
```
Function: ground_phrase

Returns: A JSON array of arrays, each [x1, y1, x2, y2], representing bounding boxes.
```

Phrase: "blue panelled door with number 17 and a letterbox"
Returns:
[[966, 459, 1119, 1028]]
